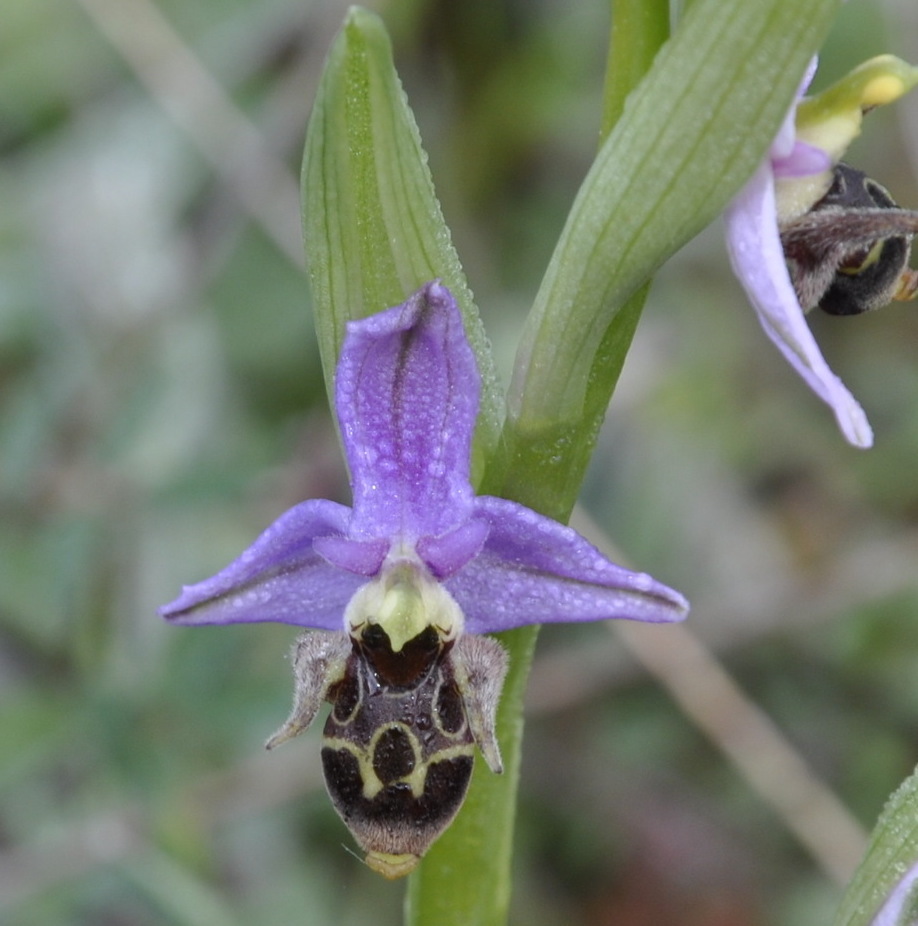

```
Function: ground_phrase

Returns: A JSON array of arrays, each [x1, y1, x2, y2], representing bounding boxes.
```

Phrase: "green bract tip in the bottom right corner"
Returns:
[[834, 769, 918, 926]]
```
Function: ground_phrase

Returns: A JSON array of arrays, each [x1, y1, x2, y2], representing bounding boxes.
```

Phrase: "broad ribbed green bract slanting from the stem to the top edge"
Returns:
[[509, 0, 839, 468]]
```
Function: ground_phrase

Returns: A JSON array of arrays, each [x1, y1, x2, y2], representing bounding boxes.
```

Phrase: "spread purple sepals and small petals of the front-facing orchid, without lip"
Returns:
[[159, 281, 688, 633]]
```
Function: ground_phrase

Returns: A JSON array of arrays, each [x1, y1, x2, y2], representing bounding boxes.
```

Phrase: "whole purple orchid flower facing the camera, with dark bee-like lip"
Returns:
[[160, 281, 688, 878]]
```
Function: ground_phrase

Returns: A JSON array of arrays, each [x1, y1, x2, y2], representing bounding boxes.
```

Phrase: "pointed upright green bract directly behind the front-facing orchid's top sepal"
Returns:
[[302, 1, 502, 462]]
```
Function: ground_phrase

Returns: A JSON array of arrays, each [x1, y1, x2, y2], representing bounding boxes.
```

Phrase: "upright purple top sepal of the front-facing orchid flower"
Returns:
[[335, 281, 480, 539]]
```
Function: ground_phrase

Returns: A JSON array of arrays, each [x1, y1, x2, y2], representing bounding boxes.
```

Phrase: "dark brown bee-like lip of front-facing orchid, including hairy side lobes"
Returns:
[[268, 624, 506, 878]]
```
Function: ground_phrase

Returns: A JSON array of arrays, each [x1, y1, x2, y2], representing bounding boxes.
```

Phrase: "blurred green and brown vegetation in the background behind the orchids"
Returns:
[[0, 0, 918, 926]]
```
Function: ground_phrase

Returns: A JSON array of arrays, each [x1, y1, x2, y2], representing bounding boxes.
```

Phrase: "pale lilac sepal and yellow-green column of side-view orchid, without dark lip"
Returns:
[[724, 55, 918, 448]]
